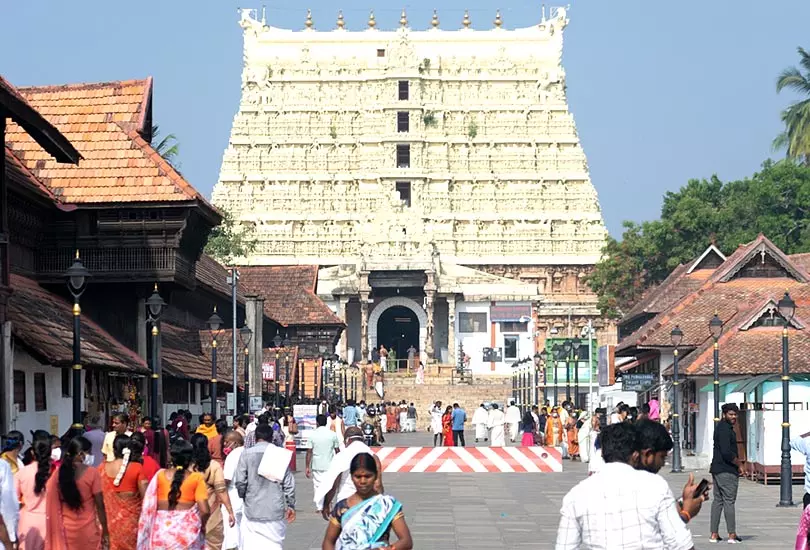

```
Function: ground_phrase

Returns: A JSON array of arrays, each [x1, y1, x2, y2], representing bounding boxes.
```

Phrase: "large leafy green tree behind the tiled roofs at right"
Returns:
[[588, 160, 810, 317]]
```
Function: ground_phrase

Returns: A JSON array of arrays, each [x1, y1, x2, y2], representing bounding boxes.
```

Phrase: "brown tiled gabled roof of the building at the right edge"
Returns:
[[617, 236, 810, 375]]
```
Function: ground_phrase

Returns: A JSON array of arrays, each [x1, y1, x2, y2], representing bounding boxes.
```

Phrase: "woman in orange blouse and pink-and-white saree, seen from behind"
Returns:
[[137, 440, 211, 550]]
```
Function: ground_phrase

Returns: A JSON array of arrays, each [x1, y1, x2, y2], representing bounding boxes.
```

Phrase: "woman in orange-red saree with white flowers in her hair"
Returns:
[[98, 434, 149, 550]]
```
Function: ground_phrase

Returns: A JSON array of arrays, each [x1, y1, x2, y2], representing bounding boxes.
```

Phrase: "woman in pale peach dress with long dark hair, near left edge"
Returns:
[[17, 440, 51, 550]]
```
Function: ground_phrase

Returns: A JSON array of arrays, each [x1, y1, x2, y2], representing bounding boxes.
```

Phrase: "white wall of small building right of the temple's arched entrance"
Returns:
[[455, 302, 535, 375]]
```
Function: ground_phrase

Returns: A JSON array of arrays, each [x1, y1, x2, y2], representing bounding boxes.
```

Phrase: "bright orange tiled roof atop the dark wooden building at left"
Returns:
[[6, 78, 213, 215]]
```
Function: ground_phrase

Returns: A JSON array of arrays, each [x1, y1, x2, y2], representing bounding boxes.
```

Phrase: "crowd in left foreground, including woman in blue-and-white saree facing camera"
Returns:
[[0, 404, 412, 550]]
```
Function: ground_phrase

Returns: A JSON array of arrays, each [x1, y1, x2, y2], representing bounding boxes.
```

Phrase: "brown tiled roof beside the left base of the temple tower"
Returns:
[[239, 265, 344, 326]]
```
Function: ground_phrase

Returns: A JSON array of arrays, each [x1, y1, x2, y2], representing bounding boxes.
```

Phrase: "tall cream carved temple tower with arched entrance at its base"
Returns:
[[213, 8, 607, 380]]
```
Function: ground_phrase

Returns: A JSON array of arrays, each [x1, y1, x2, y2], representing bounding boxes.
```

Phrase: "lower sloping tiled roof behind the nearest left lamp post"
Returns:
[[8, 275, 149, 374]]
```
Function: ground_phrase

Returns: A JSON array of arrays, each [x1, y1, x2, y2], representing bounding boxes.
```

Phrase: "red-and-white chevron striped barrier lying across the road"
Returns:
[[374, 447, 562, 473]]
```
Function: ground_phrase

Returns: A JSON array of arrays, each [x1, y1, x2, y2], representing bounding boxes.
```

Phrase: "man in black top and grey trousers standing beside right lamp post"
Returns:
[[708, 403, 741, 544]]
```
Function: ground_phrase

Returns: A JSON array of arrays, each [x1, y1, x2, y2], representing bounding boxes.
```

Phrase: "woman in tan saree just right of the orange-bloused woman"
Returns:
[[191, 434, 236, 550]]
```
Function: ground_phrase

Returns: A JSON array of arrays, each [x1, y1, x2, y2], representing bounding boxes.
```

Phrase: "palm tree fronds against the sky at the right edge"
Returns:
[[773, 48, 810, 166]]
